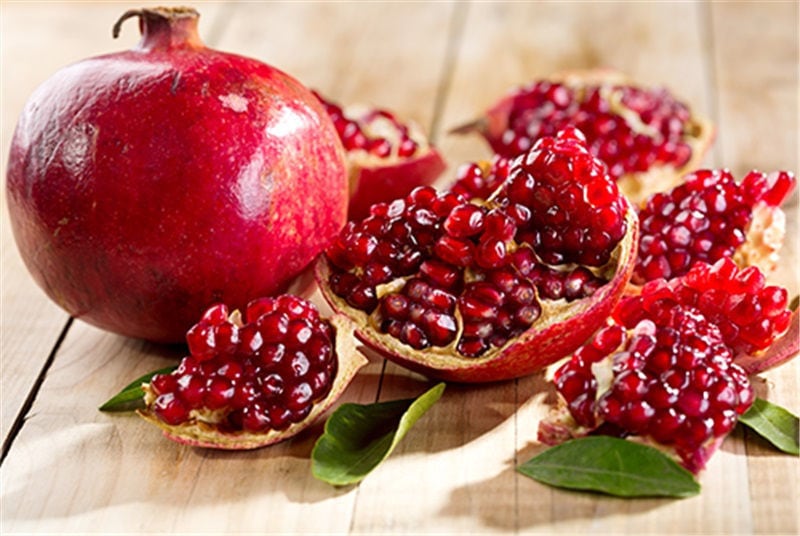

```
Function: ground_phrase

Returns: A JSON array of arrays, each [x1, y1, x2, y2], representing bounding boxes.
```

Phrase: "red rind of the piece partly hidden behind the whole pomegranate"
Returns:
[[347, 145, 447, 221]]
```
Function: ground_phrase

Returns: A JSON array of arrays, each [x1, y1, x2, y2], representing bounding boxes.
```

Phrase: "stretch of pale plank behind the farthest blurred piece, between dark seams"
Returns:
[[435, 2, 711, 174]]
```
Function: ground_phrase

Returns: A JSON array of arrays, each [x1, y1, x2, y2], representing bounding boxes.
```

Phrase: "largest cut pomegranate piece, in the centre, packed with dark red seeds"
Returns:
[[317, 129, 637, 382]]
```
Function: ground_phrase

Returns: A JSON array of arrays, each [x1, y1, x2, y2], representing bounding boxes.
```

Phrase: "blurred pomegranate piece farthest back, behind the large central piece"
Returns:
[[454, 70, 714, 202]]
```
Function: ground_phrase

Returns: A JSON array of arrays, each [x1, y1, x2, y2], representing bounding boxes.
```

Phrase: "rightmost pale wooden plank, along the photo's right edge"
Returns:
[[709, 2, 800, 534]]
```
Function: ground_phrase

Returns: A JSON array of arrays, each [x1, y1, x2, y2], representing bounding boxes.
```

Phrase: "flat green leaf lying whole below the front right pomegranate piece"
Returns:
[[517, 436, 700, 497]]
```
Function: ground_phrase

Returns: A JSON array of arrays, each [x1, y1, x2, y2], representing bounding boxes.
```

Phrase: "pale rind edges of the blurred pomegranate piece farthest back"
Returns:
[[451, 68, 716, 204]]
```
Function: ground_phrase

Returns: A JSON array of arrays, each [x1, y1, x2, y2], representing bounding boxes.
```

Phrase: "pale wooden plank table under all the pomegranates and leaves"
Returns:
[[0, 2, 800, 534]]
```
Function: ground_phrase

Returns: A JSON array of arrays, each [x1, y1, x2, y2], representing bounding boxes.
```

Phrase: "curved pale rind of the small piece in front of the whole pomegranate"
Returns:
[[137, 315, 367, 450]]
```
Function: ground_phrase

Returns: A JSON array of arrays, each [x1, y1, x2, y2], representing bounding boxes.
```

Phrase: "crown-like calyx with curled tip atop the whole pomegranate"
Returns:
[[111, 7, 204, 50]]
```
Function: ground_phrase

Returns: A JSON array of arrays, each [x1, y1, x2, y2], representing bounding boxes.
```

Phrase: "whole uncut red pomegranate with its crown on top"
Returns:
[[7, 8, 347, 342]]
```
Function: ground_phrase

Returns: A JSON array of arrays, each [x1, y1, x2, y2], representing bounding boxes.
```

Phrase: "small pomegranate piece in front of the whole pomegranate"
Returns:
[[140, 295, 365, 450]]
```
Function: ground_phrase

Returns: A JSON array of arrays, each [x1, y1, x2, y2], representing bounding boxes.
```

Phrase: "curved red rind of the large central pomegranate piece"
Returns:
[[316, 204, 639, 383]]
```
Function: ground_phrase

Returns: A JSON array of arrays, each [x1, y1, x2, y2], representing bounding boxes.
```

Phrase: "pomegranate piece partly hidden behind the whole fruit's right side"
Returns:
[[315, 92, 447, 220]]
